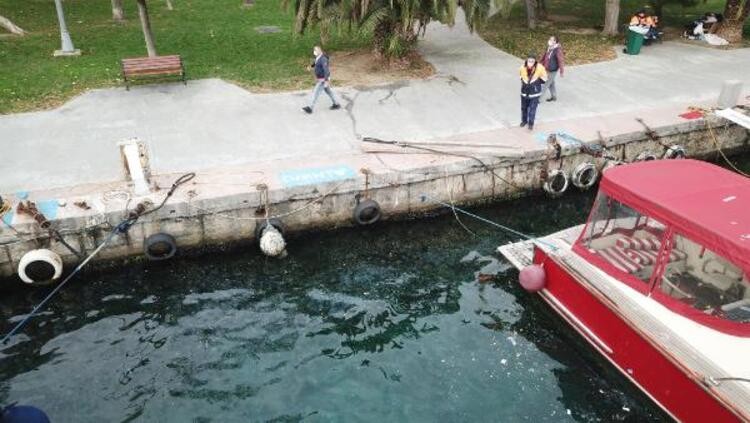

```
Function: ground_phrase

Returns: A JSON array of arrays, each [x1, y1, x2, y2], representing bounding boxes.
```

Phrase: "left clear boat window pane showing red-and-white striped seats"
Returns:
[[578, 192, 665, 288]]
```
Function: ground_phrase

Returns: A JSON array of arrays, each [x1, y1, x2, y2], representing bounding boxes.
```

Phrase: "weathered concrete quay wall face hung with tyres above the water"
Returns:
[[0, 118, 750, 285]]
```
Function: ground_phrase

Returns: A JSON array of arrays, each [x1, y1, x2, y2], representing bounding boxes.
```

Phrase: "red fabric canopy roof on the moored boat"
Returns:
[[600, 160, 750, 272]]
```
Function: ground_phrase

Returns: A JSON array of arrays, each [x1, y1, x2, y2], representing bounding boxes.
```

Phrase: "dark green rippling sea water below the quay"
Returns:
[[0, 193, 665, 422]]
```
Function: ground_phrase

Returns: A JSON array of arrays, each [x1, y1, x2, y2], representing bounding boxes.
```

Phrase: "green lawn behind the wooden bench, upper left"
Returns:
[[0, 0, 369, 113]]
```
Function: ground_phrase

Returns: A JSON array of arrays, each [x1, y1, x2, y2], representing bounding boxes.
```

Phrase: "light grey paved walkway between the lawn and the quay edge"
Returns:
[[0, 12, 750, 193]]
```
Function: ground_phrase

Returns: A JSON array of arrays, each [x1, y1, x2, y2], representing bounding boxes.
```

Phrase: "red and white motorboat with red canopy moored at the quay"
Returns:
[[499, 160, 750, 422]]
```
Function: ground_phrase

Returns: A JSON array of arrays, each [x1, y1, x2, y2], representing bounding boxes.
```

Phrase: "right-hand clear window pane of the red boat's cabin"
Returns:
[[658, 233, 750, 322]]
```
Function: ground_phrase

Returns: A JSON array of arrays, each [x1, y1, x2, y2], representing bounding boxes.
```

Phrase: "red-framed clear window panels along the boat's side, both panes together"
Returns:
[[575, 192, 750, 335]]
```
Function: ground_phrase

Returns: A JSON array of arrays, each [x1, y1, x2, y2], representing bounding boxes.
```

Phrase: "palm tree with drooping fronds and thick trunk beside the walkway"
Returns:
[[284, 0, 492, 56]]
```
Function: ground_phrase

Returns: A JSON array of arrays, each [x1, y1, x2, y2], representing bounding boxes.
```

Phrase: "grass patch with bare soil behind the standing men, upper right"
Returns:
[[480, 0, 750, 64]]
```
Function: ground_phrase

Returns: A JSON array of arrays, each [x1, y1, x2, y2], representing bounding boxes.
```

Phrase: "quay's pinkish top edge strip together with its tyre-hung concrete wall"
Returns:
[[0, 101, 750, 283]]
